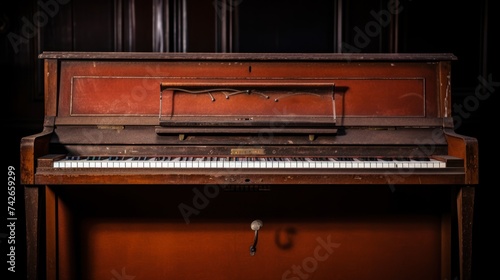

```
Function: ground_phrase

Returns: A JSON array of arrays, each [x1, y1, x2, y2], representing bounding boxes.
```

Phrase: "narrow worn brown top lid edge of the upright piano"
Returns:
[[38, 51, 457, 62]]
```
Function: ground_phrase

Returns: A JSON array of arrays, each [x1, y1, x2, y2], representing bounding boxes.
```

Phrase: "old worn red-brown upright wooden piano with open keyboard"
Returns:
[[20, 52, 478, 280]]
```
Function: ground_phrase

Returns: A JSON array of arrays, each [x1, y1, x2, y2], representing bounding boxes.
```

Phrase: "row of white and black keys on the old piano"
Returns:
[[53, 156, 446, 169]]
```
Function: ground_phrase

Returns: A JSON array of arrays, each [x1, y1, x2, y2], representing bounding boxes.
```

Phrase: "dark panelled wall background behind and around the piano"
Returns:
[[0, 0, 500, 279]]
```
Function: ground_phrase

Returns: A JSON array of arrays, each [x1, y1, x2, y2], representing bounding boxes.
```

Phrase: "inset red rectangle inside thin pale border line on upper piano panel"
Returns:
[[70, 76, 426, 117]]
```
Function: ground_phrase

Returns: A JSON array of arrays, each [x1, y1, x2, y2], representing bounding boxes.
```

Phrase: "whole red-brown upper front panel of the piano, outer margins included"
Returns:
[[58, 61, 441, 118]]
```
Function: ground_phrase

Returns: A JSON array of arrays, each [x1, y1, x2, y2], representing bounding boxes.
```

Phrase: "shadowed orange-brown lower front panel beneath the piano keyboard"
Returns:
[[47, 185, 452, 280]]
